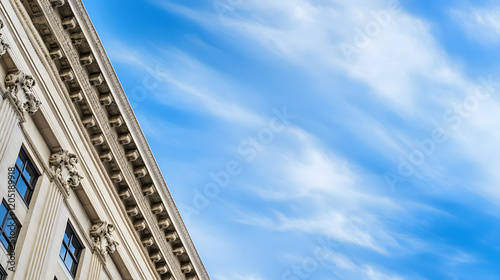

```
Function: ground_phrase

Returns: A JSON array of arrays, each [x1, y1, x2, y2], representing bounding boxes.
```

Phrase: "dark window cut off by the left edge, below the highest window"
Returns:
[[0, 201, 21, 252]]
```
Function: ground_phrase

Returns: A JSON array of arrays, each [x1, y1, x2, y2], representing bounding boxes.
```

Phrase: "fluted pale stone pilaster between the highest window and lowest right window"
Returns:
[[24, 182, 63, 279]]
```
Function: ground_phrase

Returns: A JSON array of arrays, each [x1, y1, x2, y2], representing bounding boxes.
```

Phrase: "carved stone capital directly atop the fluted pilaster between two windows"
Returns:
[[49, 150, 83, 193]]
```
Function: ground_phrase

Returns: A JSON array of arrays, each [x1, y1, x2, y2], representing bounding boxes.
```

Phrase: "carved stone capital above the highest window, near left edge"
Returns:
[[5, 70, 41, 115]]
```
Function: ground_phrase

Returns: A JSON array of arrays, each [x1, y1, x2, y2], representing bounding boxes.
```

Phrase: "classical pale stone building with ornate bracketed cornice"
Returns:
[[0, 0, 209, 280]]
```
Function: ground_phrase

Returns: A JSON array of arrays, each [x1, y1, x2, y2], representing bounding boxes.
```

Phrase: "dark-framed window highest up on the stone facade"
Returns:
[[14, 148, 38, 205]]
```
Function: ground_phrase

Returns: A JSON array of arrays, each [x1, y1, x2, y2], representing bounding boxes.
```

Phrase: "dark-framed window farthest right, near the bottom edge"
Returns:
[[59, 224, 82, 277]]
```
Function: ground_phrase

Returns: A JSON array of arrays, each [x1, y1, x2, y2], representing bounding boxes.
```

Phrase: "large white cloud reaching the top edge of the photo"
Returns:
[[157, 0, 469, 113]]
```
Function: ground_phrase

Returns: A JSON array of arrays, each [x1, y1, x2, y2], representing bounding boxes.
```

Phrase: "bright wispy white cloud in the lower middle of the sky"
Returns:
[[237, 128, 428, 254]]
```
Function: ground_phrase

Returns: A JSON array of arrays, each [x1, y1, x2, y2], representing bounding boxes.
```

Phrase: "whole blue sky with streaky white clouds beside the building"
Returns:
[[84, 0, 500, 280]]
